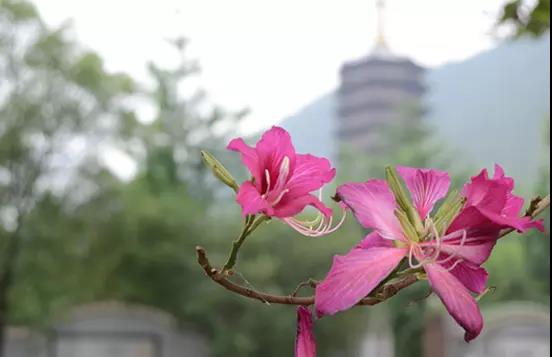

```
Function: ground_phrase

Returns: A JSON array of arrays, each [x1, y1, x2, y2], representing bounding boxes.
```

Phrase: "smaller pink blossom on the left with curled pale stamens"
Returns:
[[228, 127, 342, 236]]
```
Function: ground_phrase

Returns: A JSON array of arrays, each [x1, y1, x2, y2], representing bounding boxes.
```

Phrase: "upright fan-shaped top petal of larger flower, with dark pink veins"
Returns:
[[397, 167, 450, 219]]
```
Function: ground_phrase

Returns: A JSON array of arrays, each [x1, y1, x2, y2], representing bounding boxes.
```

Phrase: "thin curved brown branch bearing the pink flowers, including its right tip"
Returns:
[[196, 195, 550, 306]]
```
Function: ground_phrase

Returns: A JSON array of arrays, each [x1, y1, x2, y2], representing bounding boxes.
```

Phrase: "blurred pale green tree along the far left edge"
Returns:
[[0, 0, 134, 351]]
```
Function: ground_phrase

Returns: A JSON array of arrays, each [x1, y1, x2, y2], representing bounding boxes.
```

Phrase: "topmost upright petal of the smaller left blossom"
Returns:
[[256, 126, 296, 183]]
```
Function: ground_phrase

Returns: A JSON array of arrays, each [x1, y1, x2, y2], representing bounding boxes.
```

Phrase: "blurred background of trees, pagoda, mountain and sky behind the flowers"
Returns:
[[0, 0, 550, 357]]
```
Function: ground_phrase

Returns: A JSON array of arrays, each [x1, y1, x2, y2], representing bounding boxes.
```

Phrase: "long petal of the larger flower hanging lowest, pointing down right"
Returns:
[[424, 264, 483, 342]]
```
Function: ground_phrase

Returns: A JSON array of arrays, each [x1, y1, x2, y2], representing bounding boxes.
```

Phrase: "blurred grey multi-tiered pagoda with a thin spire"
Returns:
[[337, 0, 425, 152]]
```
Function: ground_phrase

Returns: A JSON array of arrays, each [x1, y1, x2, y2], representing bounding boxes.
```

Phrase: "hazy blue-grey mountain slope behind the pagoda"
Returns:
[[282, 36, 550, 179]]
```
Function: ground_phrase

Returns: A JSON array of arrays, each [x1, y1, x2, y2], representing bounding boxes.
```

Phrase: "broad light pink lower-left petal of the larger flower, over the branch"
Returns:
[[315, 248, 406, 316]]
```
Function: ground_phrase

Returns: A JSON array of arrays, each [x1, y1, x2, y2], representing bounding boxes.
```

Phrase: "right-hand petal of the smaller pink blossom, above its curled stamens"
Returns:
[[286, 155, 336, 197]]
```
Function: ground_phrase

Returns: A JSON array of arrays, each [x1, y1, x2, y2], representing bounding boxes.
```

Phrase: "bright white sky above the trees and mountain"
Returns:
[[35, 0, 520, 131]]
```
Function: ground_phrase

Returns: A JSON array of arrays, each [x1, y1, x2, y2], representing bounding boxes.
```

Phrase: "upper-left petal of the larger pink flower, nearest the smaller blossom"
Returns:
[[337, 180, 405, 240]]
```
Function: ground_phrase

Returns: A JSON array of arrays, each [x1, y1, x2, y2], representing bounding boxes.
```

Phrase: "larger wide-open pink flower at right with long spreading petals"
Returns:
[[316, 166, 544, 342]]
